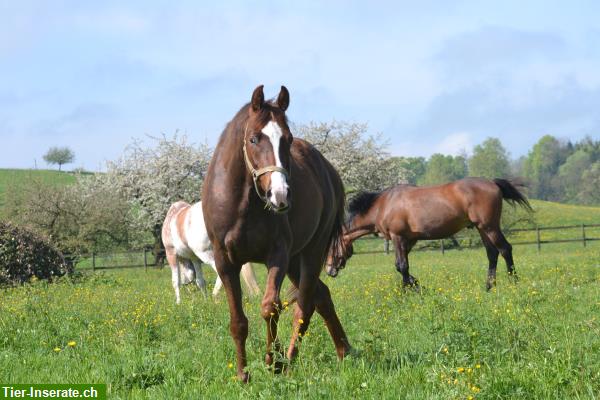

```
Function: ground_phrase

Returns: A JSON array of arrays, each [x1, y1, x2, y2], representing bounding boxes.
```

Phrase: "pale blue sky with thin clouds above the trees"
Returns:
[[0, 0, 600, 170]]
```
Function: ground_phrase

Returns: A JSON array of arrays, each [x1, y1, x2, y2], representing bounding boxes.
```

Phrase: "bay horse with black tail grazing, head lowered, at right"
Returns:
[[327, 178, 532, 290]]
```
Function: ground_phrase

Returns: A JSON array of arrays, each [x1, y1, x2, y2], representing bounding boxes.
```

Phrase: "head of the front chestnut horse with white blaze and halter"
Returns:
[[243, 85, 293, 213]]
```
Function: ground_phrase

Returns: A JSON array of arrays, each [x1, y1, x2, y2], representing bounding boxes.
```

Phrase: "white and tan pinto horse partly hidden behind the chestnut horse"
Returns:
[[162, 201, 260, 304]]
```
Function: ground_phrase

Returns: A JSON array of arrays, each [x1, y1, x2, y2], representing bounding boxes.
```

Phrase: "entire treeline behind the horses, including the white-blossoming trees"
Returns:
[[3, 122, 600, 261]]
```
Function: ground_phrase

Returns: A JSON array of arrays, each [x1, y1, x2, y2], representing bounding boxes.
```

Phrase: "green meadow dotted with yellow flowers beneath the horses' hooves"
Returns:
[[0, 242, 600, 399]]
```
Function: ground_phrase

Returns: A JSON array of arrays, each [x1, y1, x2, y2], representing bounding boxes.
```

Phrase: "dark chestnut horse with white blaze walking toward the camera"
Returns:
[[202, 86, 350, 382]]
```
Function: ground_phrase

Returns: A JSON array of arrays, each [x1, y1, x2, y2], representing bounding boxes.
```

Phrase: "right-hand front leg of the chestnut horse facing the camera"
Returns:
[[261, 246, 288, 372]]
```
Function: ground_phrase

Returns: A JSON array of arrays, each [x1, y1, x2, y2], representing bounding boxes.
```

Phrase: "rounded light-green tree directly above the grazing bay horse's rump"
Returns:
[[469, 138, 510, 178]]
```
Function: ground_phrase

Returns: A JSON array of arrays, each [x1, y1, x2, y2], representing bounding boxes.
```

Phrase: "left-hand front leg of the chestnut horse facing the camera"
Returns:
[[215, 252, 250, 382]]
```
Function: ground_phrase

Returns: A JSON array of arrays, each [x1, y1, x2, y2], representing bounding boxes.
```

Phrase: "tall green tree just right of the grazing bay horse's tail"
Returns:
[[523, 135, 573, 200]]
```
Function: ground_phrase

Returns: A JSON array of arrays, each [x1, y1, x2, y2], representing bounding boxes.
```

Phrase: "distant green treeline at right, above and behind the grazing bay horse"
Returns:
[[390, 135, 600, 205]]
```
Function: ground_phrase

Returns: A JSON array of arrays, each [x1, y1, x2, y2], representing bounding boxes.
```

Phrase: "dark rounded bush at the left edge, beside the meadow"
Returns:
[[0, 222, 72, 285]]
